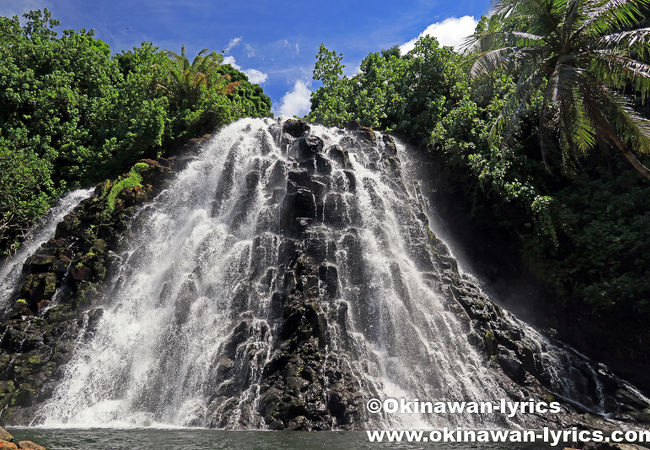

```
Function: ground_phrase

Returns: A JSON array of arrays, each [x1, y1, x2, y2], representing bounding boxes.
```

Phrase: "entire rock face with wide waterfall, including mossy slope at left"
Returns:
[[0, 119, 650, 430]]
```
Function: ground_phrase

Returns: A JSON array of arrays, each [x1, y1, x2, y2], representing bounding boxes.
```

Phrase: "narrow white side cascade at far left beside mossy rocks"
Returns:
[[0, 189, 94, 310]]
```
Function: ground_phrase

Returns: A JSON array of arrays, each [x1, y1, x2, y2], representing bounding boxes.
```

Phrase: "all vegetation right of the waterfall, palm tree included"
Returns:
[[308, 0, 650, 380]]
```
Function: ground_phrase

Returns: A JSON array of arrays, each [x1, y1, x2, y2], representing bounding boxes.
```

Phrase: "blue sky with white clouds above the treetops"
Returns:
[[0, 0, 489, 115]]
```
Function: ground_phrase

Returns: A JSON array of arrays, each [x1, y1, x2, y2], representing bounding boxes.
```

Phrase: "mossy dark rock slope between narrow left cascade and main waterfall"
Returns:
[[0, 136, 208, 424]]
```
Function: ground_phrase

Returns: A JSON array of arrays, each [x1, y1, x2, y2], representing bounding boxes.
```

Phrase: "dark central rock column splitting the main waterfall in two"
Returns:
[[200, 125, 364, 430]]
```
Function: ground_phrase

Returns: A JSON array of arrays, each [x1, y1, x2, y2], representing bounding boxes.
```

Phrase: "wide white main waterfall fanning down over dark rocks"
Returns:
[[35, 119, 644, 428]]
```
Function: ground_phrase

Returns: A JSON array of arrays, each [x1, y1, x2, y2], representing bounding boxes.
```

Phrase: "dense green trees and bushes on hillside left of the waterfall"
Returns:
[[0, 10, 271, 255]]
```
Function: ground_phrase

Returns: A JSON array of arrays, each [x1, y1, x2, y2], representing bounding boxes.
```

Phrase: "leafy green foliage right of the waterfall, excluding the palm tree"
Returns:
[[308, 9, 650, 334]]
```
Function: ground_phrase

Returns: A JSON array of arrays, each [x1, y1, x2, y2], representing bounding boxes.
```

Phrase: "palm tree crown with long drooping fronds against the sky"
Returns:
[[466, 0, 650, 179]]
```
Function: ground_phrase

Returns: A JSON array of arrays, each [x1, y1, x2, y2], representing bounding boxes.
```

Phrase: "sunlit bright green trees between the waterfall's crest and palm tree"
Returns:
[[309, 36, 467, 141]]
